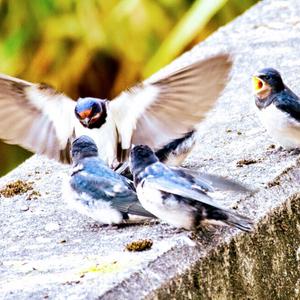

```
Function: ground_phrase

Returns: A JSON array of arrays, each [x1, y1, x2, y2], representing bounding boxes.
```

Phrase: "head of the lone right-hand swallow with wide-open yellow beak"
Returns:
[[252, 68, 284, 101]]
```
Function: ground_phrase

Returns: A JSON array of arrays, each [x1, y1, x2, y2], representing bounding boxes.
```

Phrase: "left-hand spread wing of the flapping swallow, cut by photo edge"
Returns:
[[0, 74, 77, 162]]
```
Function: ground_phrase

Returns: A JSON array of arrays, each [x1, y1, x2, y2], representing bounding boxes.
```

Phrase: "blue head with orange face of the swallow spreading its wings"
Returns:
[[75, 98, 107, 129]]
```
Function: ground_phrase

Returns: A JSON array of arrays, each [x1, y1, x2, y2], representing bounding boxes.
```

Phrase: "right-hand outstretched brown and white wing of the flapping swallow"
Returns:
[[110, 54, 232, 159]]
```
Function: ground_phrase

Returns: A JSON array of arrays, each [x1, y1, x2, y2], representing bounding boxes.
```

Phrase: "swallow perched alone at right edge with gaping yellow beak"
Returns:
[[252, 68, 300, 150]]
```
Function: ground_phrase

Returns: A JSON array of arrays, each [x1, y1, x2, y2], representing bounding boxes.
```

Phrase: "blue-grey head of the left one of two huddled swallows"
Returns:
[[71, 135, 98, 163]]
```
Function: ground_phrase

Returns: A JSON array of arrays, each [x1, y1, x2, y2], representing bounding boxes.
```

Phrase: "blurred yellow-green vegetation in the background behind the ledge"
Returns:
[[0, 0, 257, 176]]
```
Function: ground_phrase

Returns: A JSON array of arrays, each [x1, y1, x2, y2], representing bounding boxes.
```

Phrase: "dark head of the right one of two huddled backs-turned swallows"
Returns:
[[129, 145, 158, 175]]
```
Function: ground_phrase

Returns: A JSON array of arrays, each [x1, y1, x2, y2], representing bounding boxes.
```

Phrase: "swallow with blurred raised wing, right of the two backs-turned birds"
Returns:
[[130, 145, 252, 231]]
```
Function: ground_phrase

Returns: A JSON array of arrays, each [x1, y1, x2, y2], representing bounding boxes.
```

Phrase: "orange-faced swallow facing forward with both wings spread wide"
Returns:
[[0, 54, 232, 167]]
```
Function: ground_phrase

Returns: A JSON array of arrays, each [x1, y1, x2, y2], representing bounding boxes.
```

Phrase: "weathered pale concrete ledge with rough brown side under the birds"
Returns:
[[0, 0, 300, 299]]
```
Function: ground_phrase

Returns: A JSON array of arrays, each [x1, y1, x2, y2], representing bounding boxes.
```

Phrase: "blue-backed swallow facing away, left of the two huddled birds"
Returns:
[[63, 136, 154, 225]]
